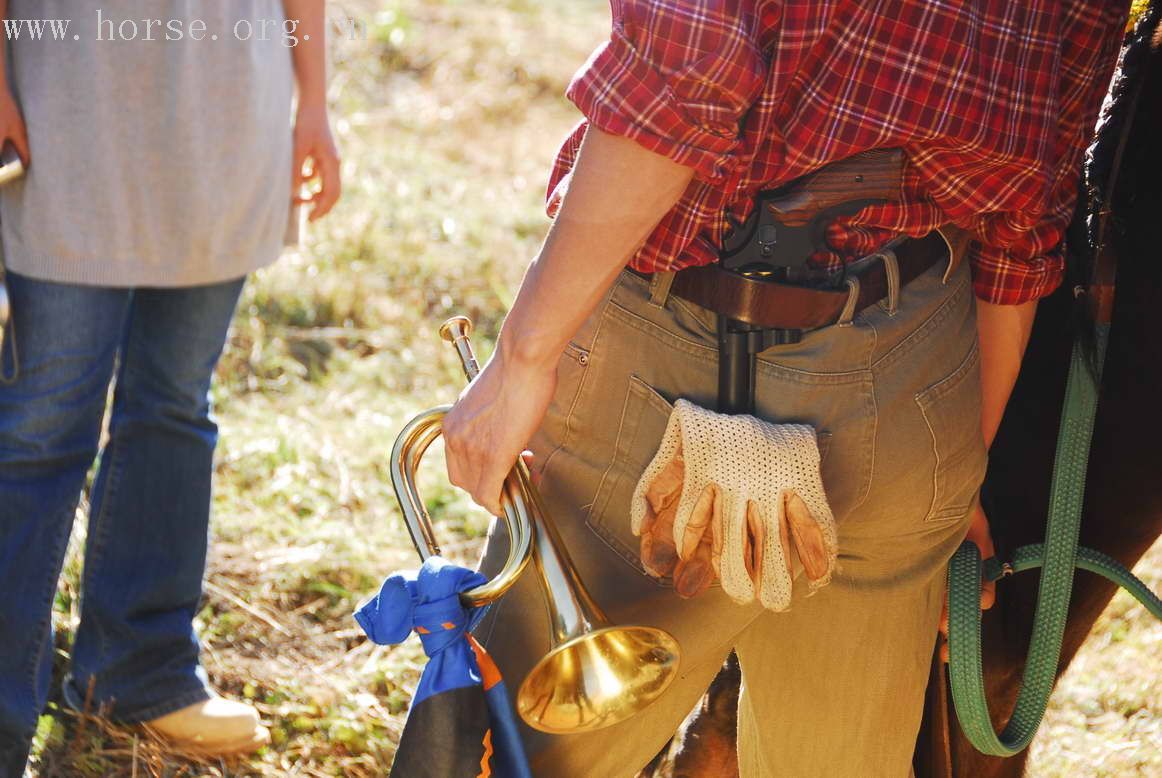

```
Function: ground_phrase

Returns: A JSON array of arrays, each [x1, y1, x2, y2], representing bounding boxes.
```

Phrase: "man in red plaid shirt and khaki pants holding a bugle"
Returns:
[[444, 0, 1128, 777]]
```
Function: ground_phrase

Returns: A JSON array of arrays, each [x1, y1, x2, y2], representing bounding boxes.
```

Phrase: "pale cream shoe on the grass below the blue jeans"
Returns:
[[145, 697, 271, 755]]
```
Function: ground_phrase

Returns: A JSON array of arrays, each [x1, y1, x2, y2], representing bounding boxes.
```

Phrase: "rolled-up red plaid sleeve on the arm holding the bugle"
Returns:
[[566, 0, 767, 185]]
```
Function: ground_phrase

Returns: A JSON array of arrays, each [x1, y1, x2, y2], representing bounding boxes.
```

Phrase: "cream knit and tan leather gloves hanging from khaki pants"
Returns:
[[630, 399, 837, 611]]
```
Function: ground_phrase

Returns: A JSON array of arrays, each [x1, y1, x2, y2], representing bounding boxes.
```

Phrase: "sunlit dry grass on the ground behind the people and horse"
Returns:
[[27, 0, 1162, 778]]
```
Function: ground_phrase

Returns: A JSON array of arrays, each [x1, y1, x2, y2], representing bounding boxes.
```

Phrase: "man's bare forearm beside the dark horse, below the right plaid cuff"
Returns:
[[976, 300, 1037, 446]]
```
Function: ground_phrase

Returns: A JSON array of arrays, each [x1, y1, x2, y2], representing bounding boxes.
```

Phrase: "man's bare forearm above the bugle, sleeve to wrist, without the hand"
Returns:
[[500, 128, 693, 368]]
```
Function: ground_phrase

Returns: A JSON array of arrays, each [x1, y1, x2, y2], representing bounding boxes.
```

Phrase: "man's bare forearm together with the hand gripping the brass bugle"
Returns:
[[443, 128, 694, 516]]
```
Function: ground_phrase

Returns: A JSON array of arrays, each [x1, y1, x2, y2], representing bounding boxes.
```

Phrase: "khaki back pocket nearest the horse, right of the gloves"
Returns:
[[916, 344, 988, 521]]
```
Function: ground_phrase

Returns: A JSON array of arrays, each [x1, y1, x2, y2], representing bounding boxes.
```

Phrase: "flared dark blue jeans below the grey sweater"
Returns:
[[0, 274, 244, 776]]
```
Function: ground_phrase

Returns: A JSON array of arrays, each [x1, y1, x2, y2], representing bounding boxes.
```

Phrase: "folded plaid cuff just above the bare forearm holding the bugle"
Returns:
[[566, 29, 761, 185]]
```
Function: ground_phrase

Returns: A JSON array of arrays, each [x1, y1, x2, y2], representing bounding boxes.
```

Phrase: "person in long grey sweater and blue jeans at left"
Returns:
[[0, 0, 339, 776]]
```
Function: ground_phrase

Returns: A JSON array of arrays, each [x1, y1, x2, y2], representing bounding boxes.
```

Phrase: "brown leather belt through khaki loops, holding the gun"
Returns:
[[638, 228, 967, 330]]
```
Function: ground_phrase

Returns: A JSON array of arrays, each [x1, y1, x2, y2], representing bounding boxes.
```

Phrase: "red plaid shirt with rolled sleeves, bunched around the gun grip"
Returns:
[[548, 0, 1128, 304]]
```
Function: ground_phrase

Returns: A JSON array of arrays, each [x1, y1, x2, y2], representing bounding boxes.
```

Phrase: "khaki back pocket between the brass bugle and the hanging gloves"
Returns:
[[586, 375, 673, 584]]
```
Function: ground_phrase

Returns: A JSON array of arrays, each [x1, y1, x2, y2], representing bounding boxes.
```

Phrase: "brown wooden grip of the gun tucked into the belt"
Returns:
[[767, 149, 904, 226]]
